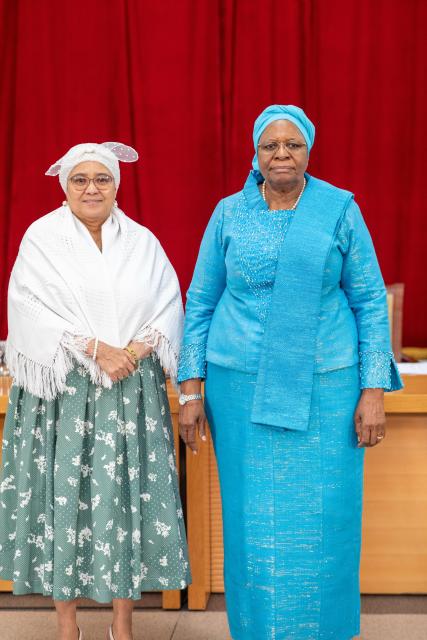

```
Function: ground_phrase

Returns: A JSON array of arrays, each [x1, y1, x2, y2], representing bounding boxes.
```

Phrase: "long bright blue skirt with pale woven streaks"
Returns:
[[206, 363, 364, 640]]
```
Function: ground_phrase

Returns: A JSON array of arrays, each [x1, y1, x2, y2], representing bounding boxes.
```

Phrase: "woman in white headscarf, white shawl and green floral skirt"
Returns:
[[0, 143, 189, 640]]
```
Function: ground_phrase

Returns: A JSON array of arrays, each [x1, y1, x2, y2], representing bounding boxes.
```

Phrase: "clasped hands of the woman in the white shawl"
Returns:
[[86, 340, 153, 382]]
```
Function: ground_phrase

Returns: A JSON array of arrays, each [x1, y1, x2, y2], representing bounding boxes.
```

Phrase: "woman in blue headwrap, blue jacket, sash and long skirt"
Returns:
[[178, 105, 402, 640]]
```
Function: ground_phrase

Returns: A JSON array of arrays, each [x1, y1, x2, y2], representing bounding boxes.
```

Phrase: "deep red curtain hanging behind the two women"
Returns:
[[0, 0, 427, 345]]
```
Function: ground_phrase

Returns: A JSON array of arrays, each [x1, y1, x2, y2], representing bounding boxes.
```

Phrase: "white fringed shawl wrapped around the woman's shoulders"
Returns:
[[6, 207, 183, 400]]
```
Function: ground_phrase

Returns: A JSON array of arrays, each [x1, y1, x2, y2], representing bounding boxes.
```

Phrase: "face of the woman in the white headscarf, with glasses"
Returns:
[[67, 160, 116, 223]]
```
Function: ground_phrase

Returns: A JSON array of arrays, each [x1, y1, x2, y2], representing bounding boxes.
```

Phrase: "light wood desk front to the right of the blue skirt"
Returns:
[[361, 414, 427, 593]]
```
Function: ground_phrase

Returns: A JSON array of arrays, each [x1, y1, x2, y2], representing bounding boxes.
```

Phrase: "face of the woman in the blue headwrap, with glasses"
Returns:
[[258, 120, 308, 189]]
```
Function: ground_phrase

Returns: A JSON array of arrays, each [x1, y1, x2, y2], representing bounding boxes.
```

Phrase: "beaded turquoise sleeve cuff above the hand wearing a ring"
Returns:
[[359, 351, 403, 391]]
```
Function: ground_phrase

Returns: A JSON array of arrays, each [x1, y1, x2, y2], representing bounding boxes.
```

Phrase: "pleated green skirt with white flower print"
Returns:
[[0, 355, 190, 602]]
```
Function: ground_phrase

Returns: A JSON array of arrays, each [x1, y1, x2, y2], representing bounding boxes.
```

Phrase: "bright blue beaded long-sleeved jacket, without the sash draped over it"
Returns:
[[178, 172, 402, 400]]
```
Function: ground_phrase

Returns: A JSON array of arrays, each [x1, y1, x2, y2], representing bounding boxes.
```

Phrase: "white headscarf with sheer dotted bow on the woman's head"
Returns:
[[45, 142, 138, 193]]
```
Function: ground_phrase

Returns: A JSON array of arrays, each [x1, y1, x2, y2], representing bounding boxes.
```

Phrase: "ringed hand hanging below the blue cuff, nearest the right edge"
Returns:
[[354, 389, 385, 447]]
